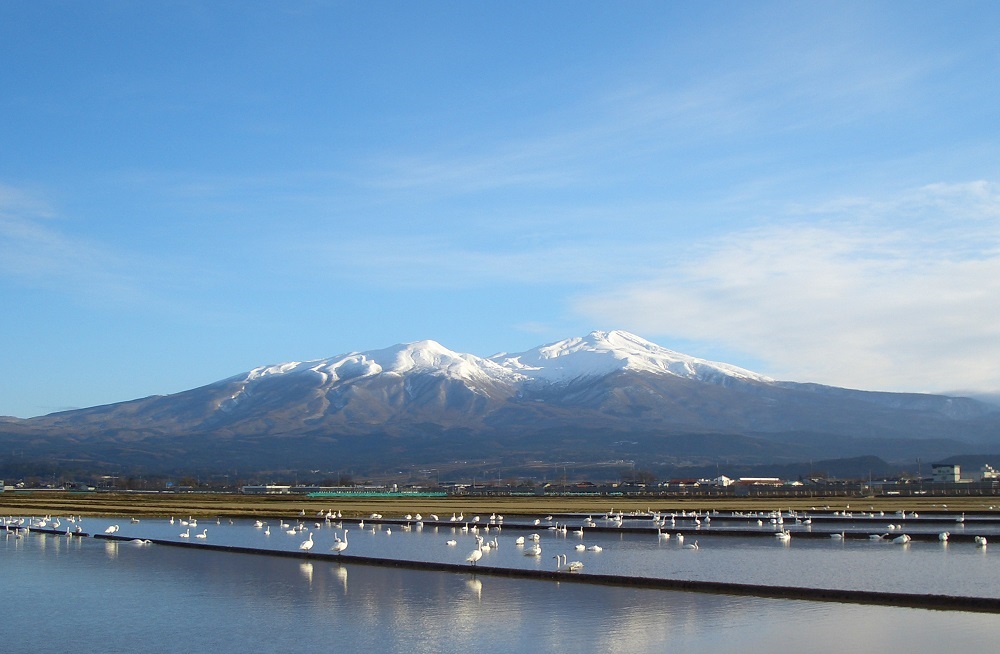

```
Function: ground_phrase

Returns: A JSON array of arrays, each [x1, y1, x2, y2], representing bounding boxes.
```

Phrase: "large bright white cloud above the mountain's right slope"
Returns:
[[575, 182, 1000, 391]]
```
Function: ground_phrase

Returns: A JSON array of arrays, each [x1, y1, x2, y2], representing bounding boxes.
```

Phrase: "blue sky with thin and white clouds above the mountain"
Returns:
[[0, 0, 1000, 417]]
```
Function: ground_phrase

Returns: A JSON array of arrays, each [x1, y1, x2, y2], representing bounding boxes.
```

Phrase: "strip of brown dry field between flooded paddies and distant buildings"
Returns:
[[0, 491, 1000, 520]]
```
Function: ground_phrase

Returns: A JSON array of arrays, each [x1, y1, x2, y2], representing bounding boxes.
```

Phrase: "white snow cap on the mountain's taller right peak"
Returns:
[[491, 330, 773, 382]]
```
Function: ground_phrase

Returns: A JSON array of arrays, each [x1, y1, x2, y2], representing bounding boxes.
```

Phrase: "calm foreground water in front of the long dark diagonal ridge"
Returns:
[[0, 534, 1000, 654]]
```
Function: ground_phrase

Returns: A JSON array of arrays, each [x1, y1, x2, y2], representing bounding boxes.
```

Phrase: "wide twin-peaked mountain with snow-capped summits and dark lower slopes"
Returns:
[[0, 331, 1000, 476]]
